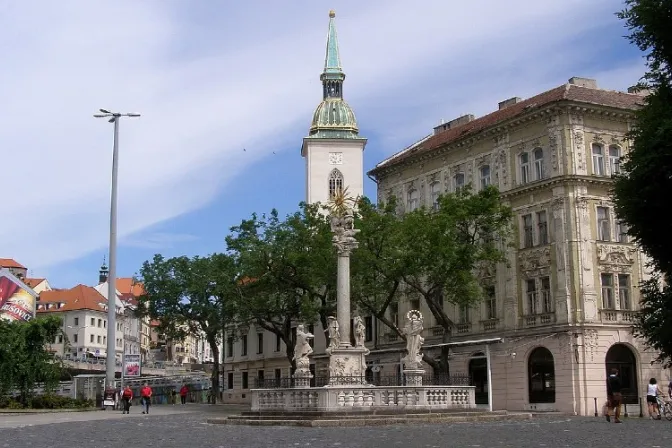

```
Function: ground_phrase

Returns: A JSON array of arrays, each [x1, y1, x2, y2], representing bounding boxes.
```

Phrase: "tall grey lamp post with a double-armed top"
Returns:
[[93, 109, 140, 387]]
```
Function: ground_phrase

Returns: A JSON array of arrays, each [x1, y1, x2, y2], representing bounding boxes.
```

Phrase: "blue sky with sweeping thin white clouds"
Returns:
[[0, 0, 644, 288]]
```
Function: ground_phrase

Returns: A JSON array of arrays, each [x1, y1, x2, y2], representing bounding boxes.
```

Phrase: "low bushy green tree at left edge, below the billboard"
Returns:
[[0, 316, 63, 406]]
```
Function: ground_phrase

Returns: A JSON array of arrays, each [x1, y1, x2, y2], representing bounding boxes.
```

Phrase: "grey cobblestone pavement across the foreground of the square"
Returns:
[[0, 405, 672, 448]]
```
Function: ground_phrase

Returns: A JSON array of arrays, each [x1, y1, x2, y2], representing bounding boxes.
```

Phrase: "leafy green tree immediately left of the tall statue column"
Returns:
[[227, 204, 336, 369]]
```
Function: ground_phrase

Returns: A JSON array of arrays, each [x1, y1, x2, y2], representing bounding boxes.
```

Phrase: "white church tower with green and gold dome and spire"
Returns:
[[301, 10, 366, 204]]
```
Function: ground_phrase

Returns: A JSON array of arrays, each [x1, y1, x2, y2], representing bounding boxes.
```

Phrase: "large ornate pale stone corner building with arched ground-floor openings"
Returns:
[[368, 77, 669, 415]]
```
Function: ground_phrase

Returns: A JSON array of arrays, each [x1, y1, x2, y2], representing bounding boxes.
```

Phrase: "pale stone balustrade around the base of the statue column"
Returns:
[[250, 386, 476, 412]]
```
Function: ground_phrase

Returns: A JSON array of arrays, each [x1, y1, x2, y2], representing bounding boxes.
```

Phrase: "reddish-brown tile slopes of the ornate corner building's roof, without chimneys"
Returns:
[[368, 84, 642, 175]]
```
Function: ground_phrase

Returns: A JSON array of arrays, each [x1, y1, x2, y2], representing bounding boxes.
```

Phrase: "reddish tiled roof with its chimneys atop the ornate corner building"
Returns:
[[368, 77, 646, 176]]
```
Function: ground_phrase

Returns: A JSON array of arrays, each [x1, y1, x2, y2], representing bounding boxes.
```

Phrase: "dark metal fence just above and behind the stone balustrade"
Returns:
[[254, 375, 471, 389]]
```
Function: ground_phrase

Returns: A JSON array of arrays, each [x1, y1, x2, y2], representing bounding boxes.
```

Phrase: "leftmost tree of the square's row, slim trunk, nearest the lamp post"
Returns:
[[140, 254, 240, 402]]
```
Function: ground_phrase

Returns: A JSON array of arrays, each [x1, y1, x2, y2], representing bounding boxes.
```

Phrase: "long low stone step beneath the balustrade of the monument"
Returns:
[[207, 412, 533, 427]]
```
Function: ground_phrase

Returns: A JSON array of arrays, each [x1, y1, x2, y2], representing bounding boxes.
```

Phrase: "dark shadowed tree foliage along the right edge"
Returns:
[[614, 0, 672, 365]]
